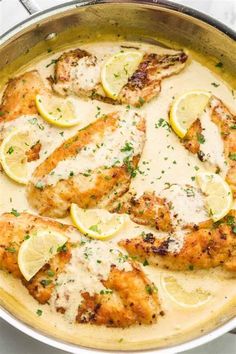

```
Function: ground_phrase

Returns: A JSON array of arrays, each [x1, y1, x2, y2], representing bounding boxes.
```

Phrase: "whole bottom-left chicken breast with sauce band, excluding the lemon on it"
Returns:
[[0, 213, 160, 327]]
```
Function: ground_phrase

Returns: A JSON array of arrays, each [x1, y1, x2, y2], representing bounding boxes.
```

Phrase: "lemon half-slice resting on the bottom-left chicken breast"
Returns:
[[18, 230, 67, 281]]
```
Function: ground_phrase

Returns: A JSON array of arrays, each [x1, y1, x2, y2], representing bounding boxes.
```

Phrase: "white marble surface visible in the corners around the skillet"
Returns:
[[0, 0, 236, 354]]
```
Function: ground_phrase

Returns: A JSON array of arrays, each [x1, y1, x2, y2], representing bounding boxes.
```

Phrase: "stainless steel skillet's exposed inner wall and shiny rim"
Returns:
[[0, 0, 236, 353]]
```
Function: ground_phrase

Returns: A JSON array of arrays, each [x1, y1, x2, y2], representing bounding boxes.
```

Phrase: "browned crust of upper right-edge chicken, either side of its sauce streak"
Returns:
[[183, 96, 236, 197]]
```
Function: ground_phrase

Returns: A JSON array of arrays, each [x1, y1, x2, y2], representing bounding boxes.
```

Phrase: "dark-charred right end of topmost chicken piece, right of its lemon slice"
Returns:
[[118, 51, 188, 107]]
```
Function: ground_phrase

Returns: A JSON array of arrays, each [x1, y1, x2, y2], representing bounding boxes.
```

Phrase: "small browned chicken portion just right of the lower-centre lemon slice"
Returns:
[[110, 192, 172, 231]]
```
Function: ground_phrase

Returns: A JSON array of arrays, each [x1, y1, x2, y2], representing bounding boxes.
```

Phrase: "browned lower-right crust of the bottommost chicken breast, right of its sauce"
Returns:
[[76, 267, 159, 327]]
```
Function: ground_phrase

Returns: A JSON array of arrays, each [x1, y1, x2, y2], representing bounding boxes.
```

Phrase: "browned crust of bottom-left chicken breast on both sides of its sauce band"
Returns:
[[0, 213, 160, 327]]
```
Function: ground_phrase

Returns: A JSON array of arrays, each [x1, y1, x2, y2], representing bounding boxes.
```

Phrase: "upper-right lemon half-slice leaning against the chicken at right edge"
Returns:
[[170, 90, 211, 138]]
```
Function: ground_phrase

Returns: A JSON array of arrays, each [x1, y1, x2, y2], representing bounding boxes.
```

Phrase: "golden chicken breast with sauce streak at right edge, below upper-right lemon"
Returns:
[[183, 96, 236, 197]]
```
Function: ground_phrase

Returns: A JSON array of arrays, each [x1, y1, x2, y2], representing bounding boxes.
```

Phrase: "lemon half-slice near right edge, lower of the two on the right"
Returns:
[[196, 172, 233, 221]]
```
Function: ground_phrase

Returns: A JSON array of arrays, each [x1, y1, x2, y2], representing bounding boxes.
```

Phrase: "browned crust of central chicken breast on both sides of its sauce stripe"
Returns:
[[28, 114, 145, 217]]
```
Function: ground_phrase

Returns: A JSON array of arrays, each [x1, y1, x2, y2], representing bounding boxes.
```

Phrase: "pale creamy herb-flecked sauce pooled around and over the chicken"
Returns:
[[0, 42, 236, 349]]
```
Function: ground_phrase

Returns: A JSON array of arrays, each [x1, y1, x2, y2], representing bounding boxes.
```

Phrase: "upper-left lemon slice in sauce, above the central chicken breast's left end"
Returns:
[[35, 95, 80, 128]]
